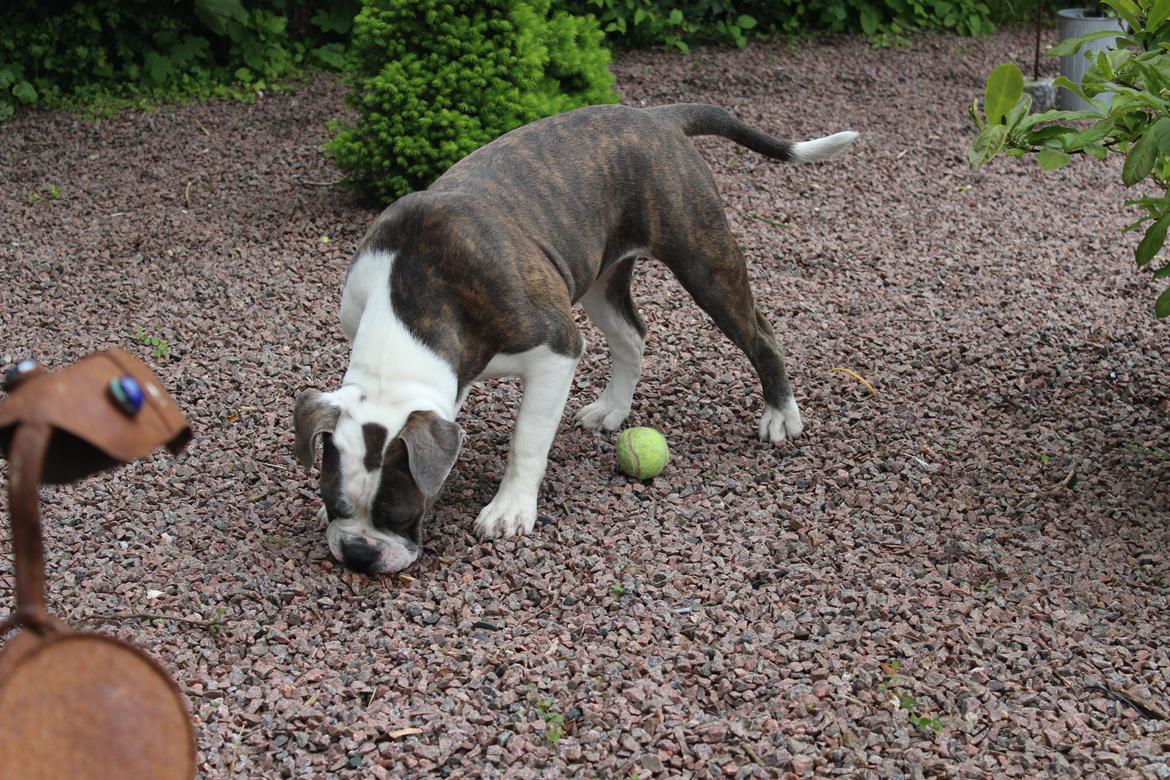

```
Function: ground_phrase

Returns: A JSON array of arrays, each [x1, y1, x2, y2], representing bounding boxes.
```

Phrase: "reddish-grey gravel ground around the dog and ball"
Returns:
[[0, 32, 1170, 779]]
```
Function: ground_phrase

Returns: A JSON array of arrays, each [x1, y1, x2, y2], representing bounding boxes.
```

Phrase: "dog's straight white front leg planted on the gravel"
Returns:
[[475, 346, 580, 539]]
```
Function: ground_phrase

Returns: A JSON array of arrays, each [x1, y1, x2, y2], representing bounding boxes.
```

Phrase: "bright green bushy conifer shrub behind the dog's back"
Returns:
[[326, 0, 618, 202]]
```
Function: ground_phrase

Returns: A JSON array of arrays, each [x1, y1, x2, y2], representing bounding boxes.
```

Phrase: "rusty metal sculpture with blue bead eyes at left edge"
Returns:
[[0, 350, 195, 779]]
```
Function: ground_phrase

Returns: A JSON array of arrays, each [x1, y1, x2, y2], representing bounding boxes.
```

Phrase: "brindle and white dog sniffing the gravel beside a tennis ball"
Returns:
[[295, 104, 856, 573]]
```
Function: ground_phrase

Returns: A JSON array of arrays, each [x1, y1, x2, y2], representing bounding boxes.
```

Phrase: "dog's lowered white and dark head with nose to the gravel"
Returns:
[[294, 386, 463, 574]]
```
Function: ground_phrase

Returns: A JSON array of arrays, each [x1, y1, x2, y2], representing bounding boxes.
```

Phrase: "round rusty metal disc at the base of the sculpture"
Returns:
[[0, 630, 195, 780]]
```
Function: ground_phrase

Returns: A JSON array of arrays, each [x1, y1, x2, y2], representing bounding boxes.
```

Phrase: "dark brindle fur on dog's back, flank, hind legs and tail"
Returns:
[[358, 105, 823, 407]]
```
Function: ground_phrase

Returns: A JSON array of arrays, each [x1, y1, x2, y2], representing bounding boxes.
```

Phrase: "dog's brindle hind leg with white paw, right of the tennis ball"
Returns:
[[658, 226, 804, 442]]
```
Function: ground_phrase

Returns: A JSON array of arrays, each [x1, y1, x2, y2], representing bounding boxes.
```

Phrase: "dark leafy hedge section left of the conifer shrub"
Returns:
[[0, 0, 358, 120]]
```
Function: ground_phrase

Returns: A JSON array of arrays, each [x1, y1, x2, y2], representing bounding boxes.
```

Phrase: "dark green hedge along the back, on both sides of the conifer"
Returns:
[[0, 0, 1038, 122]]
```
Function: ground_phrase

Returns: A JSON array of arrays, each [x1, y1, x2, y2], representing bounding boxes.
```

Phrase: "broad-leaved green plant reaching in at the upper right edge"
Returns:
[[968, 0, 1170, 317]]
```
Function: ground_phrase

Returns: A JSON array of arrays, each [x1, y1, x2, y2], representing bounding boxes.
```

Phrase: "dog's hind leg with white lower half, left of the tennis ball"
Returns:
[[577, 256, 646, 430]]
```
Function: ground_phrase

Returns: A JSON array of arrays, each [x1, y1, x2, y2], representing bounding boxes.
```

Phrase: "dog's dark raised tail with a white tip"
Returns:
[[644, 103, 858, 163]]
